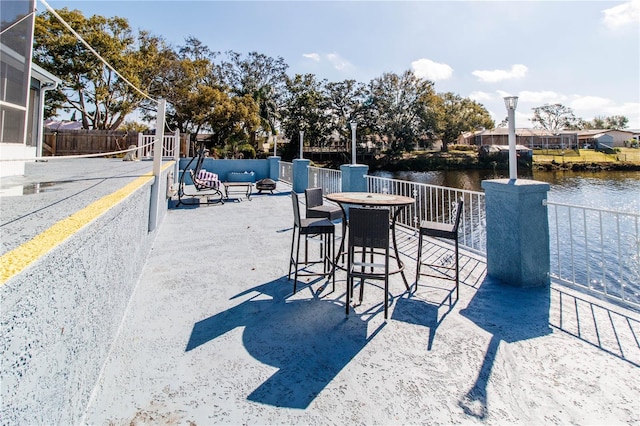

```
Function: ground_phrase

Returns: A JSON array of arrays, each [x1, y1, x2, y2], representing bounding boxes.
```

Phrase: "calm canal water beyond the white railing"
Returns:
[[372, 170, 640, 303]]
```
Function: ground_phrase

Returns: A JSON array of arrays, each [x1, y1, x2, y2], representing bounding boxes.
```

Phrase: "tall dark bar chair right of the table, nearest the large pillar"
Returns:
[[416, 199, 464, 300]]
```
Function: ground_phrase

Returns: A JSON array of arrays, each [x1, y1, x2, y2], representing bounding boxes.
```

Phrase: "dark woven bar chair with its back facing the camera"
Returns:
[[346, 208, 390, 319]]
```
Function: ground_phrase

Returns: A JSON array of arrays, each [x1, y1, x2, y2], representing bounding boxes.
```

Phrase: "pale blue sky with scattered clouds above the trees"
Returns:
[[45, 0, 640, 129]]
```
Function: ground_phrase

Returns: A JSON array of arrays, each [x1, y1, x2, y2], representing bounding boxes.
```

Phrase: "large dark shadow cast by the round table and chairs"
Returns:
[[186, 277, 384, 409]]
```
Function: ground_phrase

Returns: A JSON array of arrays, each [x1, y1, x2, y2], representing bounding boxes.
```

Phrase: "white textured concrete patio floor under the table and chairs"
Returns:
[[84, 182, 640, 425]]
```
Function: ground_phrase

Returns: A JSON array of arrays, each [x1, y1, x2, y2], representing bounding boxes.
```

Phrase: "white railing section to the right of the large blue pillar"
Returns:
[[546, 201, 640, 307]]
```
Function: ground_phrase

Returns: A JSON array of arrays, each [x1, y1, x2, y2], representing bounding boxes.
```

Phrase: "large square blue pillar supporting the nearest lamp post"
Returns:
[[482, 179, 550, 287]]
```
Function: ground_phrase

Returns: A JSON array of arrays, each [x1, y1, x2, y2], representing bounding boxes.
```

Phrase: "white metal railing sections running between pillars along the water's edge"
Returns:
[[280, 162, 640, 308]]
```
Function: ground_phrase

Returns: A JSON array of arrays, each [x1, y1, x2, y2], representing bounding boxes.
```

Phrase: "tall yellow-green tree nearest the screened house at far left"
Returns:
[[33, 8, 170, 130]]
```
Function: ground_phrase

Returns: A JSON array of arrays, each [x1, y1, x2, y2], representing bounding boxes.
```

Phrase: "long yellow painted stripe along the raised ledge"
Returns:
[[0, 162, 174, 286]]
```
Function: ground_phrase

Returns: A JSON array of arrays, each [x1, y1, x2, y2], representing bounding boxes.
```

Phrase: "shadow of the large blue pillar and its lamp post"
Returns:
[[458, 277, 552, 420]]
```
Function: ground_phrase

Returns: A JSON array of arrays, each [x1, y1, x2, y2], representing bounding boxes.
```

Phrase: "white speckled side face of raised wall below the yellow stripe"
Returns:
[[0, 167, 172, 424]]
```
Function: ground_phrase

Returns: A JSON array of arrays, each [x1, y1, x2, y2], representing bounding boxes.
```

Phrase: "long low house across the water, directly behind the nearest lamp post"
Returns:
[[457, 127, 578, 149]]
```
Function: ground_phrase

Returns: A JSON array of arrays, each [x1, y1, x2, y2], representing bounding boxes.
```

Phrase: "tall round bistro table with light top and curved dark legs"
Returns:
[[326, 192, 416, 290]]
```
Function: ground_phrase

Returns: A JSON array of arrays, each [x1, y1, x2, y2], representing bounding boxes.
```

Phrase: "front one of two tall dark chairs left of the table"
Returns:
[[287, 191, 336, 293]]
